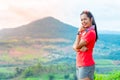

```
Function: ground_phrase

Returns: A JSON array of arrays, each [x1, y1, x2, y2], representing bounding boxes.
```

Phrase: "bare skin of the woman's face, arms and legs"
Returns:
[[73, 14, 92, 80]]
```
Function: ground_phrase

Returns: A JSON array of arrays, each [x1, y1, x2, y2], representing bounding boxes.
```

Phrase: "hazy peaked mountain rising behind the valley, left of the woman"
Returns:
[[0, 17, 77, 39]]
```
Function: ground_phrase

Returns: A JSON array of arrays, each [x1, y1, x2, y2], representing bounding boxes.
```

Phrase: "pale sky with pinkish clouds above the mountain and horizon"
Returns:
[[0, 0, 120, 31]]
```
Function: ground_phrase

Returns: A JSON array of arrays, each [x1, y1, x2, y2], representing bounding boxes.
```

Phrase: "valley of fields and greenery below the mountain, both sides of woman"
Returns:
[[0, 34, 120, 80]]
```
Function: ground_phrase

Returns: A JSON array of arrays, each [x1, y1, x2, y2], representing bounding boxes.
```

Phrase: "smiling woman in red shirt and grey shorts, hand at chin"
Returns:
[[73, 11, 98, 80]]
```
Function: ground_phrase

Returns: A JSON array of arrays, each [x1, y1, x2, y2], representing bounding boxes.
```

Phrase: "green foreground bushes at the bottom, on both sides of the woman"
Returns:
[[11, 63, 120, 80]]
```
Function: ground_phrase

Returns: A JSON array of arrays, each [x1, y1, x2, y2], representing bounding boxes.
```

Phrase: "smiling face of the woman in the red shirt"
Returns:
[[80, 14, 92, 28]]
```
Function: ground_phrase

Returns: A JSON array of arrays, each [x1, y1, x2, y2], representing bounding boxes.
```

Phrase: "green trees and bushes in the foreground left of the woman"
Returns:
[[9, 63, 75, 80]]
